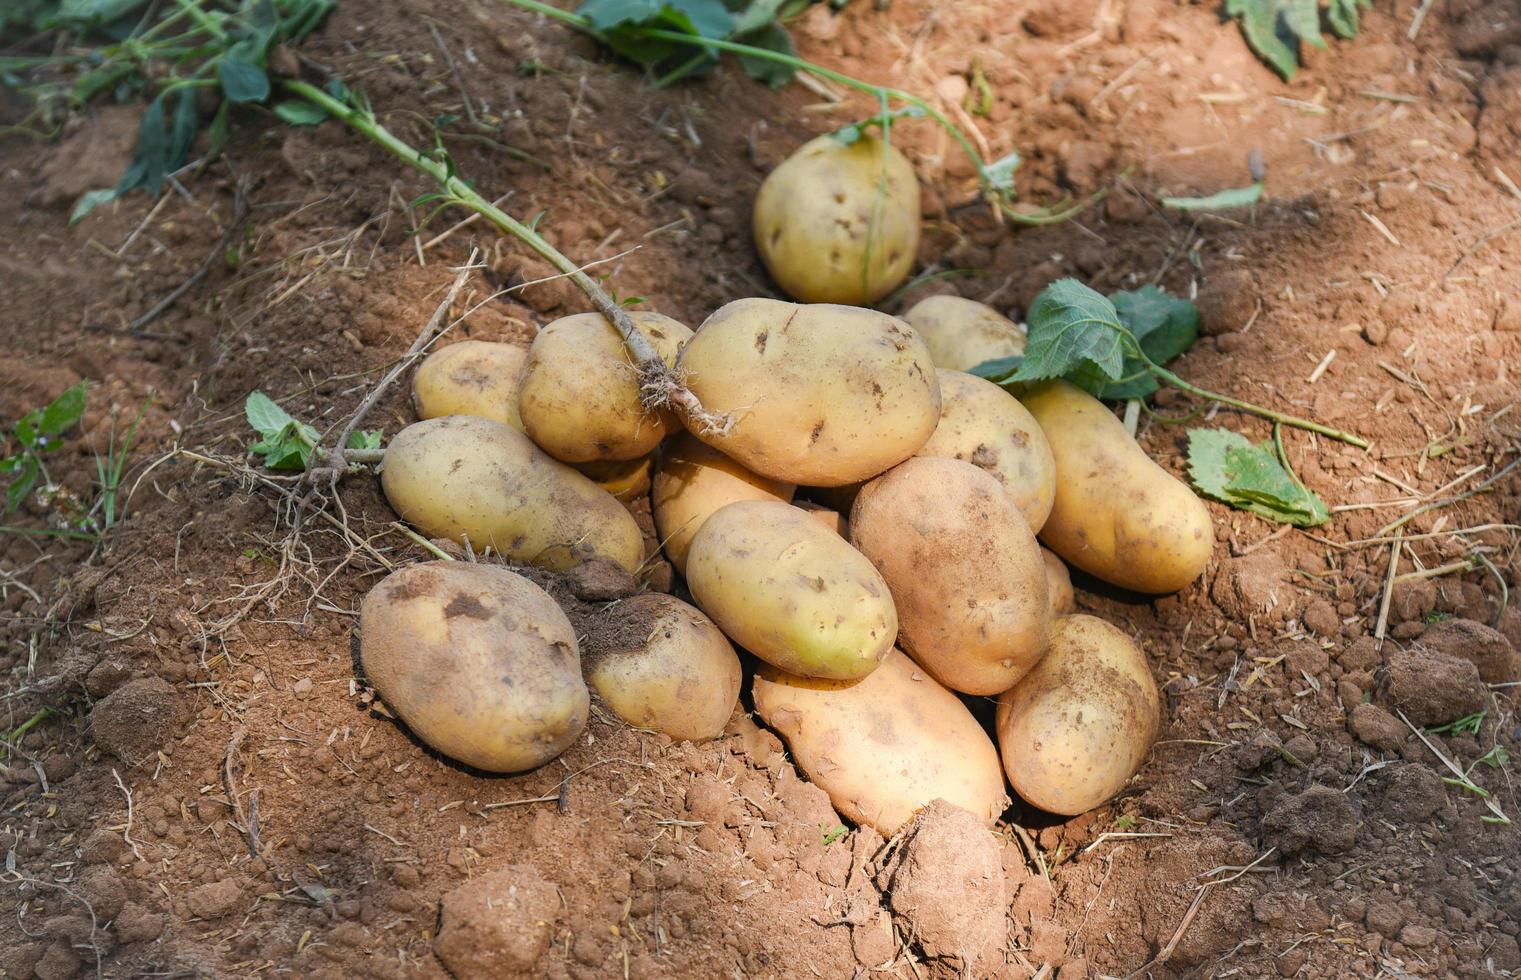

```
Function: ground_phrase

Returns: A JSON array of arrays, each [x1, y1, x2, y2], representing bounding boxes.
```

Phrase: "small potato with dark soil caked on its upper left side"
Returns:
[[583, 592, 739, 741]]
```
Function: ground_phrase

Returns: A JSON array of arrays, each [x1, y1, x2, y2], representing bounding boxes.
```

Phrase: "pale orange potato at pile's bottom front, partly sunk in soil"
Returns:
[[751, 650, 1008, 837]]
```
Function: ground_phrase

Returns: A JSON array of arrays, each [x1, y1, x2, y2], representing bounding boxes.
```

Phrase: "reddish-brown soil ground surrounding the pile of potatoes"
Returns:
[[0, 0, 1521, 978]]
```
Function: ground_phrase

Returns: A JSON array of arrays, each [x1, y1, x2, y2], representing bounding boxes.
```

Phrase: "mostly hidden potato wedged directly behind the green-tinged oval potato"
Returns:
[[649, 432, 795, 574]]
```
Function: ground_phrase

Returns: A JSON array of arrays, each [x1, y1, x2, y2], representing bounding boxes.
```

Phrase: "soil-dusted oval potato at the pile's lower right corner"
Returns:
[[995, 615, 1162, 816]]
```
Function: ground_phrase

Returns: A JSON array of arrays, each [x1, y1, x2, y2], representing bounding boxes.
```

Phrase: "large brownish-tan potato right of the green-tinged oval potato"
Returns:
[[850, 457, 1049, 694]]
